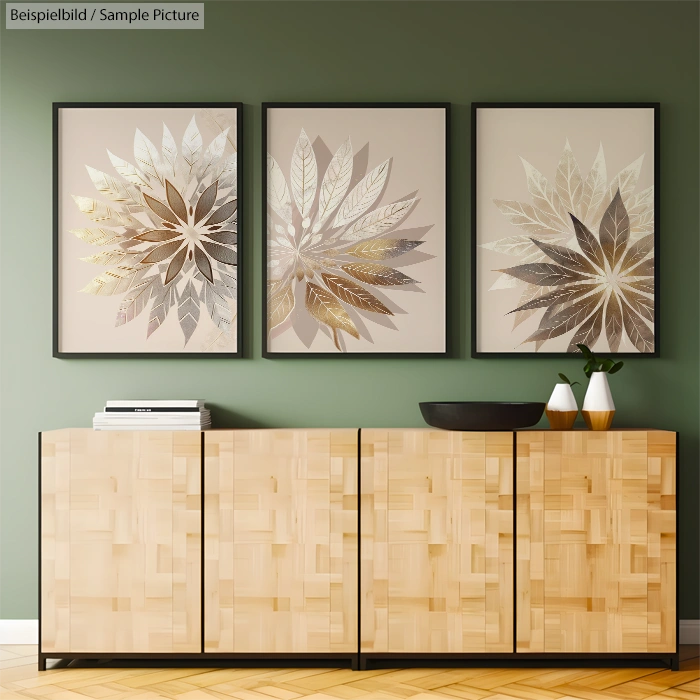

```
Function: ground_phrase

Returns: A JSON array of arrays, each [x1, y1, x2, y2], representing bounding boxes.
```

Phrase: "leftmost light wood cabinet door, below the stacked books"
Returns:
[[41, 429, 202, 653]]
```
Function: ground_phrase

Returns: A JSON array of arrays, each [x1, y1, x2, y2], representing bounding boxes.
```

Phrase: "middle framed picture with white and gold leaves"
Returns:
[[263, 103, 449, 358]]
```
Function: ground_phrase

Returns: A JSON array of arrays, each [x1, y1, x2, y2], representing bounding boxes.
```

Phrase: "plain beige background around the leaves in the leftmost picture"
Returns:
[[58, 107, 237, 353]]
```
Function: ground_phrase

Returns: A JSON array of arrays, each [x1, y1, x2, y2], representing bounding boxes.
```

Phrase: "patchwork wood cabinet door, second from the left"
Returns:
[[205, 430, 358, 653]]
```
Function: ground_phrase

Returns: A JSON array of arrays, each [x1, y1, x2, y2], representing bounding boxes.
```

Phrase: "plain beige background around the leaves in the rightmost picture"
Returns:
[[476, 108, 656, 354]]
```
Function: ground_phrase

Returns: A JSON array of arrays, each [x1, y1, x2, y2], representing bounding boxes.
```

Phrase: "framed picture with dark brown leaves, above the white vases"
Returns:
[[472, 103, 659, 357]]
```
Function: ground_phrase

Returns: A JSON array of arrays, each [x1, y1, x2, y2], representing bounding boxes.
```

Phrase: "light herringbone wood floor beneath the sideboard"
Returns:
[[0, 646, 700, 700]]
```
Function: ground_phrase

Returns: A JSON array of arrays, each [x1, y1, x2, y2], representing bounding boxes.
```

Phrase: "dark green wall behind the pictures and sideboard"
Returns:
[[0, 0, 700, 619]]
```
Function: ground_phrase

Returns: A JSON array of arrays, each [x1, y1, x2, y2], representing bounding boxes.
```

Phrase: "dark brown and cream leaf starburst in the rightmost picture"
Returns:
[[490, 140, 654, 353]]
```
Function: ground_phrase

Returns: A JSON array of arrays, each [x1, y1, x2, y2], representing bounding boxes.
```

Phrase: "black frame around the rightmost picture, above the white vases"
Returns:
[[470, 102, 661, 359]]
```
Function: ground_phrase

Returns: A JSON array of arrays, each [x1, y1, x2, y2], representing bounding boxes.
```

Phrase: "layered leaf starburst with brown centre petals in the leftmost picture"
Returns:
[[71, 113, 238, 346]]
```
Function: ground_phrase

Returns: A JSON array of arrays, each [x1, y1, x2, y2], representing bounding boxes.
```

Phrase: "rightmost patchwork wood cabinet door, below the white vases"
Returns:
[[516, 431, 676, 653]]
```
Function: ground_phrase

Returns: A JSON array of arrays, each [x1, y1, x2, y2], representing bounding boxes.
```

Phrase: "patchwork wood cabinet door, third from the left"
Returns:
[[360, 429, 514, 653]]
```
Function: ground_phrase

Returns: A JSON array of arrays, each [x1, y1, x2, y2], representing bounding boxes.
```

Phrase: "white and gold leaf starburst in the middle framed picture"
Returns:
[[266, 128, 432, 352]]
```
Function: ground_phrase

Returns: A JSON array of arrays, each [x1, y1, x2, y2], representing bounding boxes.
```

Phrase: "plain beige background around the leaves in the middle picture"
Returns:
[[267, 107, 446, 355]]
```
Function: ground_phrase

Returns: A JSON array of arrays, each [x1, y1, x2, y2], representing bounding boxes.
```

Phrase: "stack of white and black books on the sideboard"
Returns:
[[92, 399, 211, 430]]
